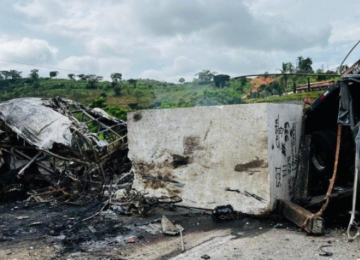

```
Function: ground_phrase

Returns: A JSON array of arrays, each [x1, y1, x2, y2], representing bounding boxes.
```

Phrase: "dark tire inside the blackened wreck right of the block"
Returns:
[[310, 131, 337, 190]]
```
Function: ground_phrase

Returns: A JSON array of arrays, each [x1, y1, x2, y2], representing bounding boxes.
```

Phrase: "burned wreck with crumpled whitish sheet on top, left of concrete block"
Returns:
[[0, 97, 130, 204]]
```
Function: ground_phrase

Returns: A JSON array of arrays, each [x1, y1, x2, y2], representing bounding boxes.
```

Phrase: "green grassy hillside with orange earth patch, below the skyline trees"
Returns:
[[0, 74, 330, 119]]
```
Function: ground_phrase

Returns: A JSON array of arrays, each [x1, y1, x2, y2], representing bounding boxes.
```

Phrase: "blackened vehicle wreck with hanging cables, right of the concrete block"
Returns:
[[296, 61, 360, 239]]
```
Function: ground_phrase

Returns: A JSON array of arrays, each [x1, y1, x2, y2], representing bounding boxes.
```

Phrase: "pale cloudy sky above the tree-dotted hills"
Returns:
[[0, 0, 360, 82]]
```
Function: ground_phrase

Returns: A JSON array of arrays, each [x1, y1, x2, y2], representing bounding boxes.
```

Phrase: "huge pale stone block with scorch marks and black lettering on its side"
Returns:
[[128, 103, 302, 215]]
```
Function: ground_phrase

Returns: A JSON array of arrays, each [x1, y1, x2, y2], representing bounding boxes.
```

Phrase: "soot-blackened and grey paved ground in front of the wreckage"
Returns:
[[0, 199, 360, 260]]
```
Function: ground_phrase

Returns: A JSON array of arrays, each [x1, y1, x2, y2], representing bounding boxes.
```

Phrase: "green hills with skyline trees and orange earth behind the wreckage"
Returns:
[[0, 57, 348, 119]]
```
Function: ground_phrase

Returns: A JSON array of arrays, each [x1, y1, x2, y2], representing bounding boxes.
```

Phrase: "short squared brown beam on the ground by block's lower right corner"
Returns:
[[276, 200, 325, 235]]
